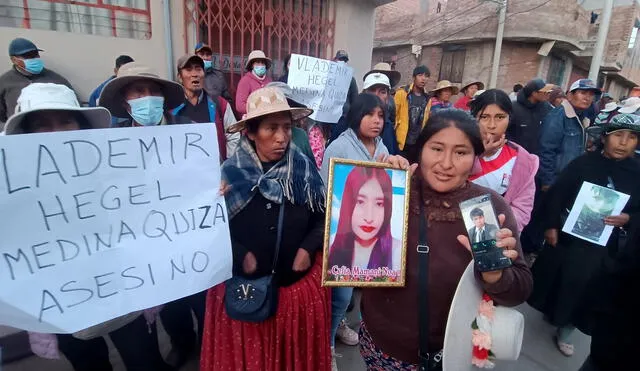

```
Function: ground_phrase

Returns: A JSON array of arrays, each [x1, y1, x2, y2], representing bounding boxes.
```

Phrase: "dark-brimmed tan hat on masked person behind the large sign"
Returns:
[[98, 62, 184, 117]]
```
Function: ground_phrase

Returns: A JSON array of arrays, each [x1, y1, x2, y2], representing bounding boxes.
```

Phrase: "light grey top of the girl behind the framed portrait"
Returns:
[[320, 128, 389, 185]]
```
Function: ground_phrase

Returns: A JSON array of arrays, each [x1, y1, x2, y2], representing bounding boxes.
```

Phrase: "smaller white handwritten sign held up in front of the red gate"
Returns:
[[287, 54, 353, 124]]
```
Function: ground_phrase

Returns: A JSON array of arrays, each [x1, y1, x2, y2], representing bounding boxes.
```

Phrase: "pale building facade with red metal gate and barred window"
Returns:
[[0, 0, 393, 101]]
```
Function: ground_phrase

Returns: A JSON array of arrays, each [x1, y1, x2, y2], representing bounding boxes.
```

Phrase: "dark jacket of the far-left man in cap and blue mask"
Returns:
[[0, 66, 73, 126]]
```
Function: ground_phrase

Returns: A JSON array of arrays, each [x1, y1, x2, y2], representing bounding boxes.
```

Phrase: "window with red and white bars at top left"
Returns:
[[0, 0, 151, 39]]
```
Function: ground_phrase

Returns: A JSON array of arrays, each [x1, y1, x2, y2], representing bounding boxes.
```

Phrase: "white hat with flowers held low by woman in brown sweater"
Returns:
[[442, 261, 524, 371]]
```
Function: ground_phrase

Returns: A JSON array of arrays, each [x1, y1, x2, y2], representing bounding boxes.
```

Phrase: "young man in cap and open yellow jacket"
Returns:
[[394, 65, 431, 161]]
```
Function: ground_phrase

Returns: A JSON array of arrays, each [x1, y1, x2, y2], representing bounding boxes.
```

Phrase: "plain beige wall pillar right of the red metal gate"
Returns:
[[333, 0, 375, 88]]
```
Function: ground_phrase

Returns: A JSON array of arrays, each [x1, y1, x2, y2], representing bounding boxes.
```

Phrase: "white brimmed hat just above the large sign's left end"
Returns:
[[5, 82, 111, 135]]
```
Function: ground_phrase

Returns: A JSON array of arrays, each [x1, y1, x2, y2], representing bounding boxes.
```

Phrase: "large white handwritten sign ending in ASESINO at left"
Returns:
[[0, 124, 232, 333]]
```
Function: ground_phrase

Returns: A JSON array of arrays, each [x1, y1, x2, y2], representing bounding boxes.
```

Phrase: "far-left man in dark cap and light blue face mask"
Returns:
[[0, 37, 73, 129]]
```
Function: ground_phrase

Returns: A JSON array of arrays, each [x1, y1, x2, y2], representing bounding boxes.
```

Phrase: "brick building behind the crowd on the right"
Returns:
[[372, 0, 640, 97]]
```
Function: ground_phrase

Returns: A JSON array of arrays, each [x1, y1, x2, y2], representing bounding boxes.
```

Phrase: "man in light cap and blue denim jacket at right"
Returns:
[[538, 79, 601, 191]]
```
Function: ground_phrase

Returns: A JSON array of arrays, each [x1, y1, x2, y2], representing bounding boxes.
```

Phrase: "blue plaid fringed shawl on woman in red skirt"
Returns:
[[222, 136, 326, 218]]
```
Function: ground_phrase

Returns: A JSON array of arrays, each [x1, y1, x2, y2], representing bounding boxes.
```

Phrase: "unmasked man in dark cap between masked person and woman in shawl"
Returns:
[[172, 54, 240, 161]]
